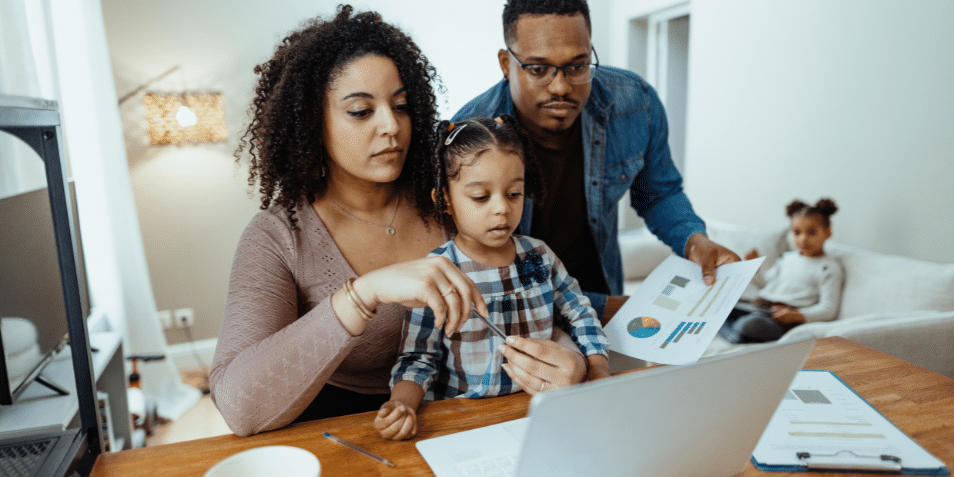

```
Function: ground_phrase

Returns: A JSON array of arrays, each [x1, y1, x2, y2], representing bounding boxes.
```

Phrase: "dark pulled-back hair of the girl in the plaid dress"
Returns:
[[430, 114, 546, 232]]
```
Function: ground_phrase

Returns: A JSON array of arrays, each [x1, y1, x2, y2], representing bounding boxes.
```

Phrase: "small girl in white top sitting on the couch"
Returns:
[[719, 199, 845, 343]]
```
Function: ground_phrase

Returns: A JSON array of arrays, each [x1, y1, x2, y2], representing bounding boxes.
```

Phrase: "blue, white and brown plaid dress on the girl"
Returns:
[[391, 235, 609, 401]]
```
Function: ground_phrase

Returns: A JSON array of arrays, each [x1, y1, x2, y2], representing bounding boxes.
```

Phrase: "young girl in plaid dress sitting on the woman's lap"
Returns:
[[374, 115, 609, 440]]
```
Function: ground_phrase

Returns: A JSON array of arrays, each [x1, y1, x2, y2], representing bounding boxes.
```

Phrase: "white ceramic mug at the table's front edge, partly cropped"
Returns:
[[205, 446, 321, 477]]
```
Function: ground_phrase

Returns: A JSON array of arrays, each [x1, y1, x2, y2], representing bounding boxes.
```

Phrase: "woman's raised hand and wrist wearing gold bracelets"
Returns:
[[354, 257, 489, 336]]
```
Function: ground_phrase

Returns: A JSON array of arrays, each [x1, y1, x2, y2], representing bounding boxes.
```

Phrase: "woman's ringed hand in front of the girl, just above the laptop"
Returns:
[[500, 336, 586, 396]]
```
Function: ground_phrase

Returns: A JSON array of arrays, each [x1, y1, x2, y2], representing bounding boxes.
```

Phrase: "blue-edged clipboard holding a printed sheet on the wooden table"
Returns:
[[751, 369, 951, 475]]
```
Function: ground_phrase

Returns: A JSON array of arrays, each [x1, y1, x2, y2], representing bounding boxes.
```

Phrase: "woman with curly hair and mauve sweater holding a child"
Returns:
[[210, 6, 586, 436]]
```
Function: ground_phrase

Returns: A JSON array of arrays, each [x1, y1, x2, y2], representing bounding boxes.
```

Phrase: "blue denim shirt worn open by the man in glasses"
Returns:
[[453, 66, 705, 316]]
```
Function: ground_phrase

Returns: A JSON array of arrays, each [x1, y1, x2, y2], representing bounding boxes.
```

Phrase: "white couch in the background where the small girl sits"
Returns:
[[620, 222, 954, 378]]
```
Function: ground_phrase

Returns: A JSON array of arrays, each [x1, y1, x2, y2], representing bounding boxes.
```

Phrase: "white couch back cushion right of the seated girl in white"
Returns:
[[831, 246, 954, 317]]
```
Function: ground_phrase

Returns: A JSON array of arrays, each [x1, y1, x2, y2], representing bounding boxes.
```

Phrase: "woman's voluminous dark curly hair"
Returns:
[[235, 5, 439, 226]]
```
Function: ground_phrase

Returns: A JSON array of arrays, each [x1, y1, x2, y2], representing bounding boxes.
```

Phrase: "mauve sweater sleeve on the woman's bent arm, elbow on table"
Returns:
[[209, 212, 355, 436]]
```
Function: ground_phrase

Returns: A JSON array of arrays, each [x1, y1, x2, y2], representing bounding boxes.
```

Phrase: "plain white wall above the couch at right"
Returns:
[[686, 0, 954, 262]]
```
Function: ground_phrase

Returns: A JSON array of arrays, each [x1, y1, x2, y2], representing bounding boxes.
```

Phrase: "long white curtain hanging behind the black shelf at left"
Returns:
[[0, 0, 201, 419]]
